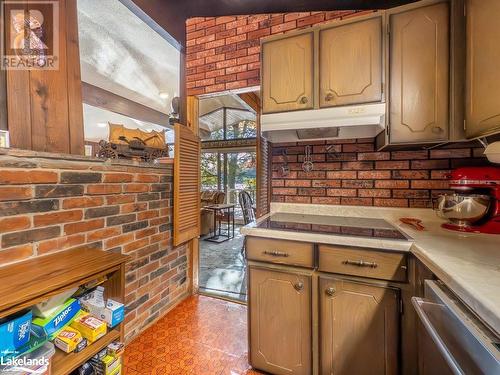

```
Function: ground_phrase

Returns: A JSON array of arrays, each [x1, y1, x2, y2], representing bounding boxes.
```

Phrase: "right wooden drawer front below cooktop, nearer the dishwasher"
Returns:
[[319, 245, 408, 281]]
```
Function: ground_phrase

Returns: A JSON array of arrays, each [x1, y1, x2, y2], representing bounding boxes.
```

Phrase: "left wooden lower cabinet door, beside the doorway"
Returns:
[[249, 267, 312, 375]]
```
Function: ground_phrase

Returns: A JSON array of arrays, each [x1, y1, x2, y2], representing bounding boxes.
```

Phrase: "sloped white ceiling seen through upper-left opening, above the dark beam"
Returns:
[[78, 0, 180, 113]]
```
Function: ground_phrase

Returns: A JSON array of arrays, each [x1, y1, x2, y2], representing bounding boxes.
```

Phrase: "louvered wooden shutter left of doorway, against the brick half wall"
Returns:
[[173, 124, 201, 245]]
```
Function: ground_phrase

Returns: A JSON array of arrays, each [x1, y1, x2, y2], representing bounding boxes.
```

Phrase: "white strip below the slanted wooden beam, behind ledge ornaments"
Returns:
[[83, 104, 174, 143]]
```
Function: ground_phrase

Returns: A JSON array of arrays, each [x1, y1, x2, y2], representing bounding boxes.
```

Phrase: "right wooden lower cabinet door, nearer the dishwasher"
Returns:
[[319, 278, 399, 375]]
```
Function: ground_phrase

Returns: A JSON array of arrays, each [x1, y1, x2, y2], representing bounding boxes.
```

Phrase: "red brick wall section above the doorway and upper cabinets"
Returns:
[[186, 11, 370, 95]]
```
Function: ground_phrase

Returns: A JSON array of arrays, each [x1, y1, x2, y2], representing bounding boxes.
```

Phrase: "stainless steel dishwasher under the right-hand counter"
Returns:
[[412, 280, 500, 375]]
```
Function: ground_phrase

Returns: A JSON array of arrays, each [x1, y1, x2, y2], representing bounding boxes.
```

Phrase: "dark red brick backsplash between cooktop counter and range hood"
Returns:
[[271, 138, 488, 207]]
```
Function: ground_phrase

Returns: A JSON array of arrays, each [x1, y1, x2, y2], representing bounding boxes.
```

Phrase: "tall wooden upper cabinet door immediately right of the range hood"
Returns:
[[388, 0, 452, 143]]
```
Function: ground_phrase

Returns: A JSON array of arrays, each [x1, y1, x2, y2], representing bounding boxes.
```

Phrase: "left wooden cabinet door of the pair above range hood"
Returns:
[[262, 32, 314, 113]]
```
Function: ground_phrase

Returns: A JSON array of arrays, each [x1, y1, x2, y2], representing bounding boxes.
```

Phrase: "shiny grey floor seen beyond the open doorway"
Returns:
[[198, 227, 246, 302]]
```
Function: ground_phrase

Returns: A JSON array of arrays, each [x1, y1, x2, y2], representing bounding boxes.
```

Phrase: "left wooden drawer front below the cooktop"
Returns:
[[245, 237, 314, 268]]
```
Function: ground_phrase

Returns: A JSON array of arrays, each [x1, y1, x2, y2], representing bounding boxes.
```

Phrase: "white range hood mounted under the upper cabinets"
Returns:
[[260, 103, 386, 143]]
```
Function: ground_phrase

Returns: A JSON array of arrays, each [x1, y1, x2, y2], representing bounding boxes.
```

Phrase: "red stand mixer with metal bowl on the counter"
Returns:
[[435, 167, 500, 234]]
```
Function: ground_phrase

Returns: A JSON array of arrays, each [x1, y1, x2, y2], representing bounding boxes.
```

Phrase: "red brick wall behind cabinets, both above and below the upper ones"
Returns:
[[186, 11, 487, 207]]
